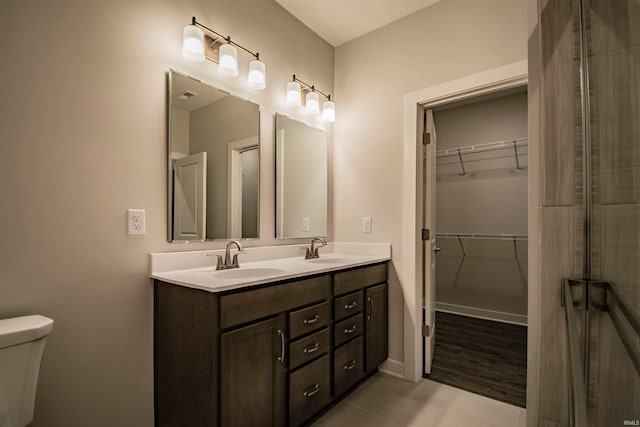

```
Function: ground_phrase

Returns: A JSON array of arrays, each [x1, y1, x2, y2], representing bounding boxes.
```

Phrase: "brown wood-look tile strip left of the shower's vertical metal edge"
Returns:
[[538, 0, 582, 426]]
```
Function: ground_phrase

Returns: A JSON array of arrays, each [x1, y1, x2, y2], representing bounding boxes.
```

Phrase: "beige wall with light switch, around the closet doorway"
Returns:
[[334, 0, 527, 370]]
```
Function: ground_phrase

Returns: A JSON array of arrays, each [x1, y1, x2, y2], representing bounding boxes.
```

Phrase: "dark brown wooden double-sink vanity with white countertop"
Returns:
[[152, 246, 388, 427]]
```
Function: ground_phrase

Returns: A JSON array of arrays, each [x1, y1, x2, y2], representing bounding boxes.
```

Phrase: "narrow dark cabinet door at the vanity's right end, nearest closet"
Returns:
[[365, 283, 389, 372]]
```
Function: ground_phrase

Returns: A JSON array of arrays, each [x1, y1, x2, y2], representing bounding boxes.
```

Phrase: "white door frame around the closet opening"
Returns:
[[399, 60, 528, 381]]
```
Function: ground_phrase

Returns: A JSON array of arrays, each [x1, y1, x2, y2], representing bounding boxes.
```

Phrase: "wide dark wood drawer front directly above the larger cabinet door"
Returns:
[[220, 275, 331, 329]]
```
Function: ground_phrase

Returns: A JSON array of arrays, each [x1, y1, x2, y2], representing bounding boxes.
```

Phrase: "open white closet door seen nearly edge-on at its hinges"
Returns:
[[422, 110, 439, 374]]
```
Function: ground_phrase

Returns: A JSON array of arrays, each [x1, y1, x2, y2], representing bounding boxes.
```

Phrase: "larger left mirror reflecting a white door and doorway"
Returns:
[[167, 70, 260, 242]]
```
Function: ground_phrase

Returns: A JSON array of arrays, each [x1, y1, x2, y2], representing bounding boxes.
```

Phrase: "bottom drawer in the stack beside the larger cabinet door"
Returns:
[[289, 355, 331, 426]]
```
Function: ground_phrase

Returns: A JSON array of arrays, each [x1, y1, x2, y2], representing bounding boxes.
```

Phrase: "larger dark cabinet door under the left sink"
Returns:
[[220, 317, 286, 427]]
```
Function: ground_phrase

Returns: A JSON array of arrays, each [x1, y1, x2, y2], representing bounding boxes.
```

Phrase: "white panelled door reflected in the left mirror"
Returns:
[[173, 152, 207, 240]]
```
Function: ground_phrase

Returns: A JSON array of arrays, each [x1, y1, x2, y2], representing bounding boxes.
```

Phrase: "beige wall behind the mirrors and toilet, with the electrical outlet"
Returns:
[[0, 0, 334, 427]]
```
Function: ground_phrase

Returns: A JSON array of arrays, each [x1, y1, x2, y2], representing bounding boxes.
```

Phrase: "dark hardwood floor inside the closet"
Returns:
[[426, 312, 527, 408]]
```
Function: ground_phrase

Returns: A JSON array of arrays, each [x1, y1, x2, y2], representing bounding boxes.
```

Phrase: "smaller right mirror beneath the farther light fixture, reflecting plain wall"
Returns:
[[275, 114, 328, 239]]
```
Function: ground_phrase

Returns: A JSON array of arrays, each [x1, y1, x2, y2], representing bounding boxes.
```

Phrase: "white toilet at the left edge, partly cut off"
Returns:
[[0, 315, 53, 427]]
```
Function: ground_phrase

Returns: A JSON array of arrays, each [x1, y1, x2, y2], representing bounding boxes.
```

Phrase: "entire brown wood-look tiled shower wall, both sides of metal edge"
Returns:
[[538, 0, 640, 426]]
